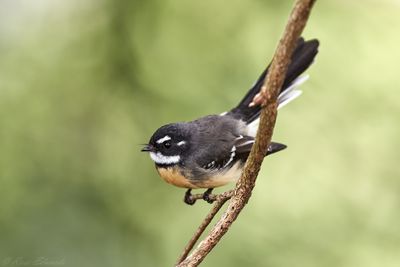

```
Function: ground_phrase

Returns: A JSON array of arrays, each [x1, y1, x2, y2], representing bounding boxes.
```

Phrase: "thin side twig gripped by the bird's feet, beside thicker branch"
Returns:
[[176, 190, 234, 264]]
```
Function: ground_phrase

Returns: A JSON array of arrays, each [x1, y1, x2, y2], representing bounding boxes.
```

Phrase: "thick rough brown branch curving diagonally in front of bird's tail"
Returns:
[[177, 0, 315, 267]]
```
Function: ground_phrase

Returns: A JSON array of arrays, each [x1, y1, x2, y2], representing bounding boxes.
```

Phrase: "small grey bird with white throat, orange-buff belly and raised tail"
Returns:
[[141, 37, 319, 205]]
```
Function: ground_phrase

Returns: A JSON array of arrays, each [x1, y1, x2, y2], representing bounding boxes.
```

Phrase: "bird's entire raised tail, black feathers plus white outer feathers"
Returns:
[[229, 38, 319, 124]]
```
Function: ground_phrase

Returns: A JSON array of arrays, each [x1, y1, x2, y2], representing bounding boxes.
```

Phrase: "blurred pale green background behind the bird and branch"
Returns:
[[0, 0, 400, 267]]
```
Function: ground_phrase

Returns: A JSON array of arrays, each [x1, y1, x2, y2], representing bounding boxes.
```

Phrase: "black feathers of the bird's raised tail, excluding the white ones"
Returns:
[[229, 38, 319, 123]]
